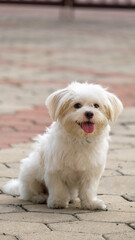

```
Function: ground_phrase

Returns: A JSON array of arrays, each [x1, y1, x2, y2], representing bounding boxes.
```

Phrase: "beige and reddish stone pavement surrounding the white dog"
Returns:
[[0, 5, 135, 240]]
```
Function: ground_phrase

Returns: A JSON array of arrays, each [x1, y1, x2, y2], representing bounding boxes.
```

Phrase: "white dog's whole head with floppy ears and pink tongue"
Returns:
[[46, 82, 123, 138]]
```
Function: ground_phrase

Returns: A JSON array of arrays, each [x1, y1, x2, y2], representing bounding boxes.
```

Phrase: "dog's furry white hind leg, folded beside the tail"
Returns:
[[19, 152, 46, 202]]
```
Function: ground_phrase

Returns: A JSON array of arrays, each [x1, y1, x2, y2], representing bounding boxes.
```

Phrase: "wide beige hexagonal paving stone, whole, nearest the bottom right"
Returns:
[[49, 221, 131, 234]]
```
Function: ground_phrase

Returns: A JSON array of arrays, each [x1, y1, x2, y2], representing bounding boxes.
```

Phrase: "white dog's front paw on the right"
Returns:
[[82, 199, 107, 211]]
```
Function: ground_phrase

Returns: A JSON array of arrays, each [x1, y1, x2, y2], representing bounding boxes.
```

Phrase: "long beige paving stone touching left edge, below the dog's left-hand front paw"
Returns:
[[0, 212, 76, 223]]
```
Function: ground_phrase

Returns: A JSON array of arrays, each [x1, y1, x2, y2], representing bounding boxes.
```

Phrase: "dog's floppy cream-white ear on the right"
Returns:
[[106, 92, 123, 122]]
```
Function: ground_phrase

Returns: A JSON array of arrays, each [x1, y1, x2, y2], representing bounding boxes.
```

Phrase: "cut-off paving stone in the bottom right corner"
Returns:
[[104, 232, 135, 240]]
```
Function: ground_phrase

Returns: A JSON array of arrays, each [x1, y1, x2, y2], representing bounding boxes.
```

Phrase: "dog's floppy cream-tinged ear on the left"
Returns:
[[45, 88, 71, 121]]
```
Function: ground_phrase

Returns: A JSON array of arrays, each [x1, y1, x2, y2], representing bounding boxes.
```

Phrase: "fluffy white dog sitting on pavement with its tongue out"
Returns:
[[3, 82, 123, 210]]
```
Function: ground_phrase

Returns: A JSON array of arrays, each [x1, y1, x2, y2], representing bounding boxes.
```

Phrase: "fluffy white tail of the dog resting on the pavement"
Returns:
[[2, 179, 20, 196]]
